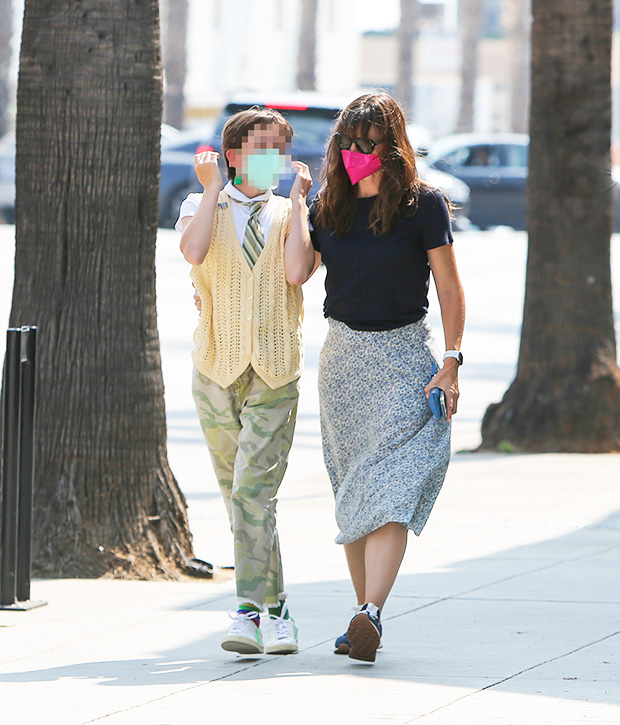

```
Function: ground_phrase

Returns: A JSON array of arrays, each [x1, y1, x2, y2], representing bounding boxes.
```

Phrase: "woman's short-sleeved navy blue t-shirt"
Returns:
[[310, 189, 453, 330]]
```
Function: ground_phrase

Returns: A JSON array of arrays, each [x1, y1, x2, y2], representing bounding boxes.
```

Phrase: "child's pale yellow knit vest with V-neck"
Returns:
[[190, 191, 303, 388]]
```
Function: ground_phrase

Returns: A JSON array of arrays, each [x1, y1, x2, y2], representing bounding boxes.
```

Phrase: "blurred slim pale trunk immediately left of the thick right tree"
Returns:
[[504, 0, 532, 133]]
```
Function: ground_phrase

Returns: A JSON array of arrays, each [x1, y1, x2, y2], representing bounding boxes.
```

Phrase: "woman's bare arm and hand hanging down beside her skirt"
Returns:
[[424, 244, 465, 420]]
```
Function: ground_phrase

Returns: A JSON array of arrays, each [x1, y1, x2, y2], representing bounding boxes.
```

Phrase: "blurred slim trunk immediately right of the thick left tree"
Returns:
[[162, 0, 188, 128]]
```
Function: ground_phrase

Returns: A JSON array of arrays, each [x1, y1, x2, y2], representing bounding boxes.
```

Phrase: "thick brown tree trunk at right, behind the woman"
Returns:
[[482, 0, 620, 453]]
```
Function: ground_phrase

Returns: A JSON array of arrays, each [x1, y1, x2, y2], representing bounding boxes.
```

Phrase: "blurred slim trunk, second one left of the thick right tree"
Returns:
[[456, 0, 484, 133]]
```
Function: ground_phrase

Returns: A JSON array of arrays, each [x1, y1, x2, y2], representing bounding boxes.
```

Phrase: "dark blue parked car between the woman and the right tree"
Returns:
[[426, 133, 529, 229]]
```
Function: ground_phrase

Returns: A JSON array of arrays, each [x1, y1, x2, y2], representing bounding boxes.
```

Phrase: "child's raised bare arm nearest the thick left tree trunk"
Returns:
[[181, 151, 222, 264]]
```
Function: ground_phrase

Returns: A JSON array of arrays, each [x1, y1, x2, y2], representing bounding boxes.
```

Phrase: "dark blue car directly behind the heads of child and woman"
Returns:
[[159, 93, 469, 228]]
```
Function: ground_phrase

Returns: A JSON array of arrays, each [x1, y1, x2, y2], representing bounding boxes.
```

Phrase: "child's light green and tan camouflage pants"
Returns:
[[192, 367, 299, 607]]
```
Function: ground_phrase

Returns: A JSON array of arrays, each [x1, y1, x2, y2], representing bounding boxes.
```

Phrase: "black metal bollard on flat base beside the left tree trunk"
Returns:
[[0, 327, 46, 611]]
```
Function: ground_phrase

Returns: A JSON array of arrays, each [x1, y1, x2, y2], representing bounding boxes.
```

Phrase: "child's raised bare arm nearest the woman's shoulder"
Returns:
[[284, 161, 318, 285]]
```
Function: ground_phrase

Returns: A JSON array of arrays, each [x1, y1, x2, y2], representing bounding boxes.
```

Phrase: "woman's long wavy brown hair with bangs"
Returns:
[[315, 92, 426, 235]]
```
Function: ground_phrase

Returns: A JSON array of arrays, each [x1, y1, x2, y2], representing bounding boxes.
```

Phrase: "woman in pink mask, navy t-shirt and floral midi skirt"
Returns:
[[300, 93, 465, 662]]
